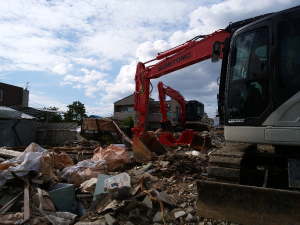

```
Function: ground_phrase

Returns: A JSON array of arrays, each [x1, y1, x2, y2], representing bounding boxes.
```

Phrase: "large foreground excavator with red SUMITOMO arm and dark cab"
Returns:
[[132, 6, 300, 225]]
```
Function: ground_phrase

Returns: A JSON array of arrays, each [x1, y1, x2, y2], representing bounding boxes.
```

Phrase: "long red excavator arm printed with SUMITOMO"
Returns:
[[132, 30, 230, 137]]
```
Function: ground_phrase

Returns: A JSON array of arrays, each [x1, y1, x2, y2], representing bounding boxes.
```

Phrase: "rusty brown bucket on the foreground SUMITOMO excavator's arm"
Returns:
[[132, 132, 167, 163]]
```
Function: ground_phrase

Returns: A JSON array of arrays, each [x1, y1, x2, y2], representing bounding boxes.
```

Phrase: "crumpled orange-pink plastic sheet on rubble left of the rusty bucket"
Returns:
[[92, 145, 130, 172]]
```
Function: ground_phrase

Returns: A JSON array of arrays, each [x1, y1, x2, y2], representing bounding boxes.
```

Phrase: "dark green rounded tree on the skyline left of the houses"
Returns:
[[64, 101, 87, 125]]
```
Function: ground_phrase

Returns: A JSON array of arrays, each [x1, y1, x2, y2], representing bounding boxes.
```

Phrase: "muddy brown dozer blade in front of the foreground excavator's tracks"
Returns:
[[196, 181, 300, 225]]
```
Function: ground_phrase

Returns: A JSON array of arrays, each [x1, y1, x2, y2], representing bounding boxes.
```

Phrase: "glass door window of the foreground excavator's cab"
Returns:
[[228, 29, 269, 118]]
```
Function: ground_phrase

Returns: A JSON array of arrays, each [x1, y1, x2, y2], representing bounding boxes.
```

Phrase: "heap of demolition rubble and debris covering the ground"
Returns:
[[0, 131, 230, 225]]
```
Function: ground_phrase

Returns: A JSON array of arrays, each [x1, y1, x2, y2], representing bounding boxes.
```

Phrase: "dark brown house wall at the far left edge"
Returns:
[[0, 82, 23, 106]]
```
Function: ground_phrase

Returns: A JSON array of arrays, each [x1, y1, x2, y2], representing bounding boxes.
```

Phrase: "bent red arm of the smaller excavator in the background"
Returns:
[[157, 82, 185, 124]]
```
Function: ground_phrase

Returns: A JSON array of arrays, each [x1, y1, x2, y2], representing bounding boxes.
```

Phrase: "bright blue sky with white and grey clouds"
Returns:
[[0, 0, 299, 116]]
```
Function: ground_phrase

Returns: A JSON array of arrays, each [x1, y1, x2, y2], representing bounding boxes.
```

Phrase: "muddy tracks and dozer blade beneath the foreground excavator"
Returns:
[[197, 143, 300, 225]]
